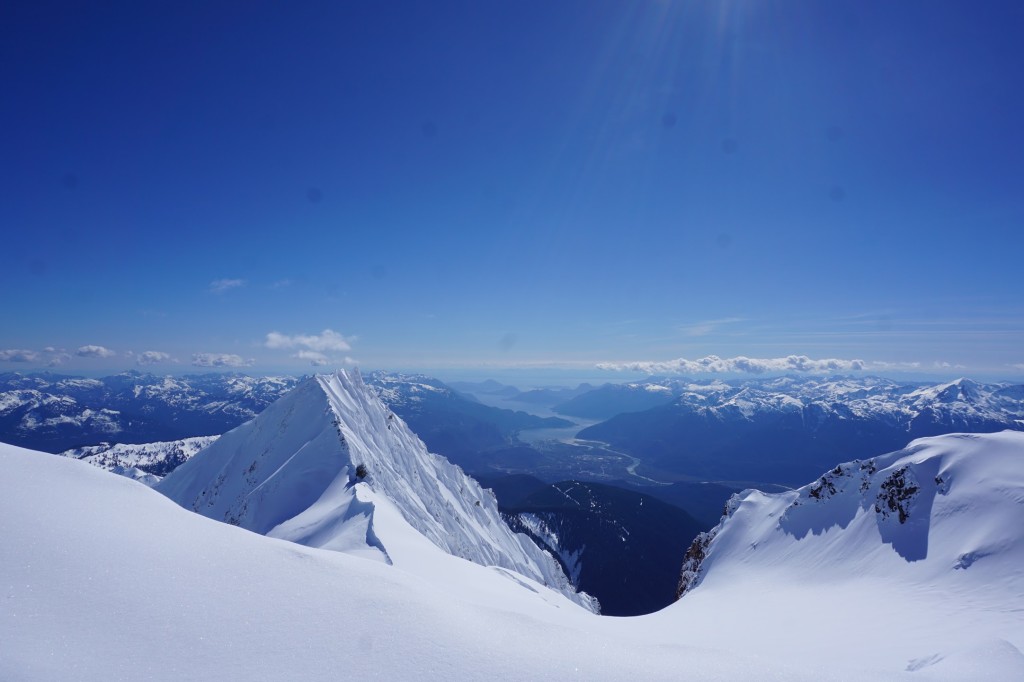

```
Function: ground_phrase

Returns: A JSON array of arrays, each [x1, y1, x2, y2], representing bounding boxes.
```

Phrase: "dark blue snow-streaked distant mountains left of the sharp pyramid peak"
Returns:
[[0, 372, 298, 453]]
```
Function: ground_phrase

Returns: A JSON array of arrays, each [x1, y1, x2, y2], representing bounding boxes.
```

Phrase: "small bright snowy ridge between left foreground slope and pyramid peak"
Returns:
[[60, 436, 218, 485]]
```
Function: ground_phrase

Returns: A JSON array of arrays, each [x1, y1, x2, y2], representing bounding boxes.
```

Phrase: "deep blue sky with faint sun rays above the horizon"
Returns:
[[0, 0, 1024, 380]]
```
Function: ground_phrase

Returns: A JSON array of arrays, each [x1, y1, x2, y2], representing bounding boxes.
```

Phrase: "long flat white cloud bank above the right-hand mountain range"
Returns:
[[597, 355, 867, 374]]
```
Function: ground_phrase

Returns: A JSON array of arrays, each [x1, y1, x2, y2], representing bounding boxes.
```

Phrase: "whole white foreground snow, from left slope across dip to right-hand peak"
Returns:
[[0, 433, 1024, 681]]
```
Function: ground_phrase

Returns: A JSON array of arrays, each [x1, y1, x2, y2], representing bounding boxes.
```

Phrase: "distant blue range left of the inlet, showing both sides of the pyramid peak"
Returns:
[[0, 372, 571, 464]]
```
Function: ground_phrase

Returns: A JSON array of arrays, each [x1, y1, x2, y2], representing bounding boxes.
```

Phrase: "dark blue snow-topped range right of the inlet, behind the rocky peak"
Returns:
[[580, 377, 1024, 485]]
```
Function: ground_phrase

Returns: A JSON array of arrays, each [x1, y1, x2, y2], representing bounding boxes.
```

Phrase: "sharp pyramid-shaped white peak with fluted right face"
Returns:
[[157, 371, 596, 609]]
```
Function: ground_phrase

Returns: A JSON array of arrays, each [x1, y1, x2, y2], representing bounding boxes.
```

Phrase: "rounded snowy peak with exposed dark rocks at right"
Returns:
[[680, 431, 1024, 601]]
